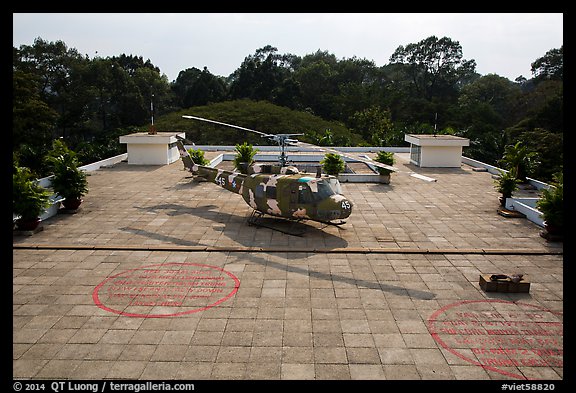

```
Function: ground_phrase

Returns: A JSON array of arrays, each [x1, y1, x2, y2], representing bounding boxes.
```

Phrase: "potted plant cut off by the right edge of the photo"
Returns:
[[536, 172, 564, 239]]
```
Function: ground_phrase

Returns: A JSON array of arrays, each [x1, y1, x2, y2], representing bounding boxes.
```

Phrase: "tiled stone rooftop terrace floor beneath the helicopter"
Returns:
[[13, 153, 563, 380]]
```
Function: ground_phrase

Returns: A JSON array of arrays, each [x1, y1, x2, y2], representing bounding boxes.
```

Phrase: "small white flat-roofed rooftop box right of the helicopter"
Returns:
[[404, 134, 470, 168]]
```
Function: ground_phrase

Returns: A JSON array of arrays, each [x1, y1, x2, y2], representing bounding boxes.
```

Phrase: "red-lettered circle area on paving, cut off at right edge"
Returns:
[[428, 299, 564, 379]]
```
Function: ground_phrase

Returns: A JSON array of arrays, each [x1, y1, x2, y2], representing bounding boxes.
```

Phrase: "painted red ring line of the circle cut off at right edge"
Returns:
[[428, 299, 563, 379]]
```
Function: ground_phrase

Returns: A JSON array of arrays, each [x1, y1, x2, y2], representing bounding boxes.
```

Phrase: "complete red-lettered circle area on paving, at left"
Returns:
[[92, 263, 240, 318]]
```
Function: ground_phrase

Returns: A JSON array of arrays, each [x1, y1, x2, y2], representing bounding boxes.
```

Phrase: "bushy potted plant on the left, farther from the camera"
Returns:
[[46, 140, 88, 210]]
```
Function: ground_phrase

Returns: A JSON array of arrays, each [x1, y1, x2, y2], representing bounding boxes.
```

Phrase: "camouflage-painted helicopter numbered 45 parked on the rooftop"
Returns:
[[176, 115, 434, 234]]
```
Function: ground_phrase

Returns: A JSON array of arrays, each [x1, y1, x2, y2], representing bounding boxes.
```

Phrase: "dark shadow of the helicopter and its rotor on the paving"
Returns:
[[121, 203, 436, 300]]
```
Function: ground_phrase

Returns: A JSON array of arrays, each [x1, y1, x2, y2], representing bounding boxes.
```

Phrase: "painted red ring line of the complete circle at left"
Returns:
[[92, 262, 240, 318]]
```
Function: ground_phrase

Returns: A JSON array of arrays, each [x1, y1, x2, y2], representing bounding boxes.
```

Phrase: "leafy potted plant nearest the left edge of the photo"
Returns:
[[12, 166, 51, 231]]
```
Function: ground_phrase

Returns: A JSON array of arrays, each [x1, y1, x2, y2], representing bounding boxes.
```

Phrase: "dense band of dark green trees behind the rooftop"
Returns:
[[12, 36, 564, 181]]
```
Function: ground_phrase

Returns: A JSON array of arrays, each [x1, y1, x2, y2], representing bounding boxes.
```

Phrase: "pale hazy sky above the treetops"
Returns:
[[12, 13, 564, 82]]
